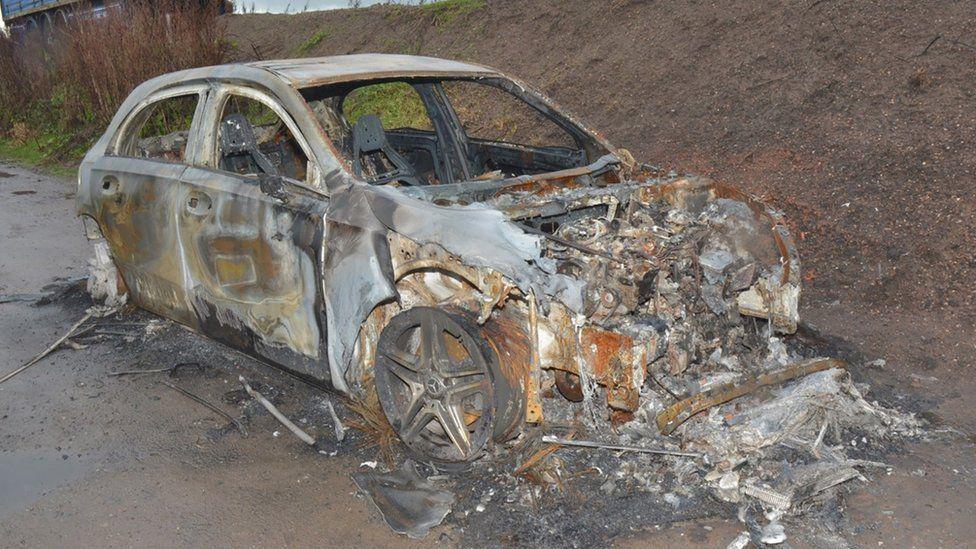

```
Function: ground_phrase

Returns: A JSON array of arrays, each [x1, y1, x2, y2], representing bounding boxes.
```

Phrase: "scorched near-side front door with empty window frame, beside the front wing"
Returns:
[[176, 86, 328, 380]]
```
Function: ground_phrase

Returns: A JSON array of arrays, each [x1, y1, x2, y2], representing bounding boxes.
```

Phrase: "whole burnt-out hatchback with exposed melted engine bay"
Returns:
[[77, 55, 800, 468]]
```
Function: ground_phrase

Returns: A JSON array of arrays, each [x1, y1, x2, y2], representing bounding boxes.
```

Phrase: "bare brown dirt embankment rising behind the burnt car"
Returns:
[[227, 0, 976, 317]]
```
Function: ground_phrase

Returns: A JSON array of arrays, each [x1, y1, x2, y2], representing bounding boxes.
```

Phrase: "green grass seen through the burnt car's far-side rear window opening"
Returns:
[[342, 82, 432, 130]]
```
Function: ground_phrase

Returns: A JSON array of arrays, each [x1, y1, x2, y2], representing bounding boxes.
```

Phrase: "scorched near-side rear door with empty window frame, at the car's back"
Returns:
[[88, 86, 207, 326]]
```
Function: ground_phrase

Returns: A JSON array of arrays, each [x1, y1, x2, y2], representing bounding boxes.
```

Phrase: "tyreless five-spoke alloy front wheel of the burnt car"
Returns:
[[376, 307, 496, 470]]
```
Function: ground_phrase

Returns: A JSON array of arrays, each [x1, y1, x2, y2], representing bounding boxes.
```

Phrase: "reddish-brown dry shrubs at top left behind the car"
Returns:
[[0, 0, 229, 150]]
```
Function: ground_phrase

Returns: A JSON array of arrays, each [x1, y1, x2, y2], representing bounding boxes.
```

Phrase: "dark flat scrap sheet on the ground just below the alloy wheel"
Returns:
[[352, 459, 454, 539]]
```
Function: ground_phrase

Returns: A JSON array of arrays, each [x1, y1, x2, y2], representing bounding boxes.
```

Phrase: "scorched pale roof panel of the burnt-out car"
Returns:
[[245, 53, 498, 88]]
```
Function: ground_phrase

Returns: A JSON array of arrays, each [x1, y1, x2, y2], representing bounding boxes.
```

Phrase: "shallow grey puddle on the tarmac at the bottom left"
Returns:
[[0, 452, 91, 517]]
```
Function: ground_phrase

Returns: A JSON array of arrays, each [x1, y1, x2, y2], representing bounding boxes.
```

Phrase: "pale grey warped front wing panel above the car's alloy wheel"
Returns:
[[323, 185, 582, 390]]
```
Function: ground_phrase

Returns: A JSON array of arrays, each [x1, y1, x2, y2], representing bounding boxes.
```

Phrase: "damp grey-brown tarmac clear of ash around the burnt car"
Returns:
[[0, 163, 976, 548]]
